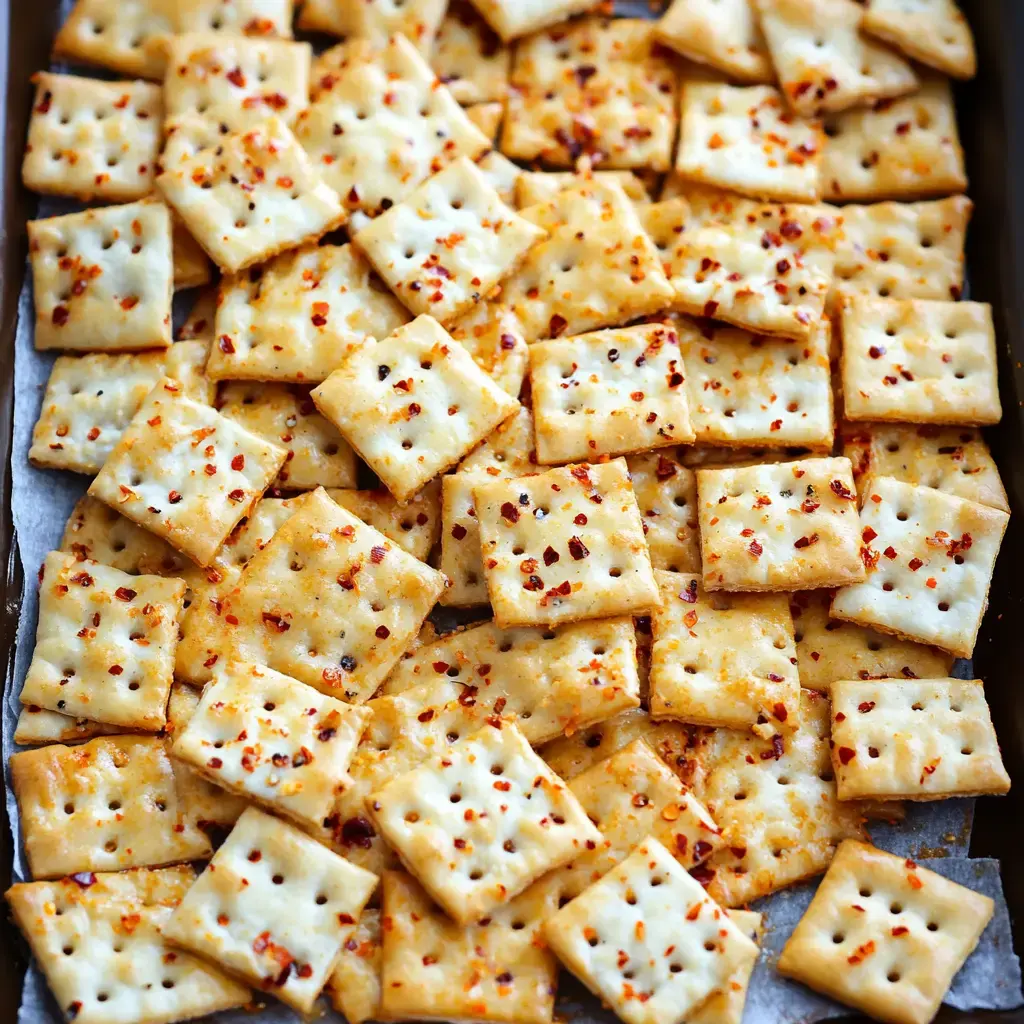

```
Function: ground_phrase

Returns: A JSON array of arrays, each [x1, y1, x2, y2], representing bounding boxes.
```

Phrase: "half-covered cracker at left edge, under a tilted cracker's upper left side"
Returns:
[[29, 341, 210, 475]]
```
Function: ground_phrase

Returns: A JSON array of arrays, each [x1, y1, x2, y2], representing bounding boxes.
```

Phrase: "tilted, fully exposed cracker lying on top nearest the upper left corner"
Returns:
[[157, 118, 346, 273]]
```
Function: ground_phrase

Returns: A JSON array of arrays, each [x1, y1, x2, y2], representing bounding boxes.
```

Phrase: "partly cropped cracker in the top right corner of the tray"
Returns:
[[860, 0, 977, 78]]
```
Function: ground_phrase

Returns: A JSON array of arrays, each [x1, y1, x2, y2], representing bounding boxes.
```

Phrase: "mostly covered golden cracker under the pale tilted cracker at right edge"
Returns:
[[790, 590, 953, 693]]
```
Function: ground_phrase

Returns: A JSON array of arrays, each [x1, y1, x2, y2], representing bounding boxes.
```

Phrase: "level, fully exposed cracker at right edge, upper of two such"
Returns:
[[841, 295, 1002, 426]]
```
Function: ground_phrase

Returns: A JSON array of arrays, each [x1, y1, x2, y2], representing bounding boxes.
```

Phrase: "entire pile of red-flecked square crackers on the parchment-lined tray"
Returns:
[[7, 0, 1010, 1024]]
